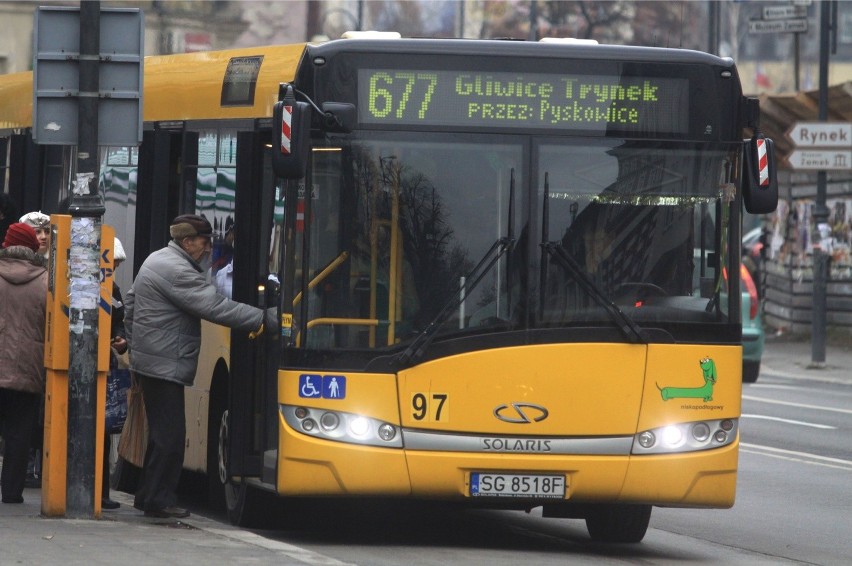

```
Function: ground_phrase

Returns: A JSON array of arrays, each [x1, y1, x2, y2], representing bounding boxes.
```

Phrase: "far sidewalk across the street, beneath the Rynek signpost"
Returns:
[[757, 333, 852, 384]]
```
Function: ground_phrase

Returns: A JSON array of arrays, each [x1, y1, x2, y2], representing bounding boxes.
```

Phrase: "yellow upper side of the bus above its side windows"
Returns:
[[0, 43, 305, 129]]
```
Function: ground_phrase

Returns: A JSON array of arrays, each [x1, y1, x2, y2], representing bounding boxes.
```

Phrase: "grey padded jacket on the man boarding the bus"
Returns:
[[124, 241, 264, 385]]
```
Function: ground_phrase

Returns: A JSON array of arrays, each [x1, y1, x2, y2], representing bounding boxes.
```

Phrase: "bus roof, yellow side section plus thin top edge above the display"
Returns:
[[0, 38, 734, 133]]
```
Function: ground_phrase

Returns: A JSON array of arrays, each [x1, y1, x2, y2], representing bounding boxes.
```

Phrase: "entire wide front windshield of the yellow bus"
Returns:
[[294, 132, 736, 349]]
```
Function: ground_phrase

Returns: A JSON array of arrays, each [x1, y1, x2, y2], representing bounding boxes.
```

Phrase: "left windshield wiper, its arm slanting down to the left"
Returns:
[[398, 169, 515, 366]]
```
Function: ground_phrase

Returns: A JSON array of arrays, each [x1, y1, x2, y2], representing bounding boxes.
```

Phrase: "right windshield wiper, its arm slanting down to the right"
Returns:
[[540, 173, 648, 344]]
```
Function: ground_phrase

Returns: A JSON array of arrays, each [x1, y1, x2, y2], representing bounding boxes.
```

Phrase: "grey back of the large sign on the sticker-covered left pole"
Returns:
[[32, 6, 145, 146]]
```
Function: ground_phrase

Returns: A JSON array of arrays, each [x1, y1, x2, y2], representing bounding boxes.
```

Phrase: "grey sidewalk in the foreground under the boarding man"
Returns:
[[0, 489, 342, 566]]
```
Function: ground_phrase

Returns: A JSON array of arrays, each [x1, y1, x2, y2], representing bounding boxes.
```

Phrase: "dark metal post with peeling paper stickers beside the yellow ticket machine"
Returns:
[[66, 1, 104, 518]]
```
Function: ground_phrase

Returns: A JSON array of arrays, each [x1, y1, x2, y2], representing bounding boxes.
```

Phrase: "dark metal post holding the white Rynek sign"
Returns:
[[811, 0, 831, 367]]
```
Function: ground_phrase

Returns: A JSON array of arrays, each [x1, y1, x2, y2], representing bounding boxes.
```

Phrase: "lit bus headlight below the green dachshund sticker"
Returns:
[[631, 419, 738, 460]]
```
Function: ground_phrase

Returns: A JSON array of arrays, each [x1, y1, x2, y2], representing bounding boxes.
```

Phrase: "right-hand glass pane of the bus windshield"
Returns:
[[540, 145, 728, 325]]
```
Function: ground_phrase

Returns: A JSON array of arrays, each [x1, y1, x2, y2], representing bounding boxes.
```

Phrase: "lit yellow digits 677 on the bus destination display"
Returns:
[[369, 71, 438, 120]]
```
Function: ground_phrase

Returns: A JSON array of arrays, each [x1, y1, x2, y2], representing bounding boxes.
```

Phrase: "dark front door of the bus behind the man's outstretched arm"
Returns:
[[228, 131, 283, 483]]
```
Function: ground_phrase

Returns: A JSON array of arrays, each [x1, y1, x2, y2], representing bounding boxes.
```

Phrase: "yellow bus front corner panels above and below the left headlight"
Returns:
[[277, 370, 411, 496]]
